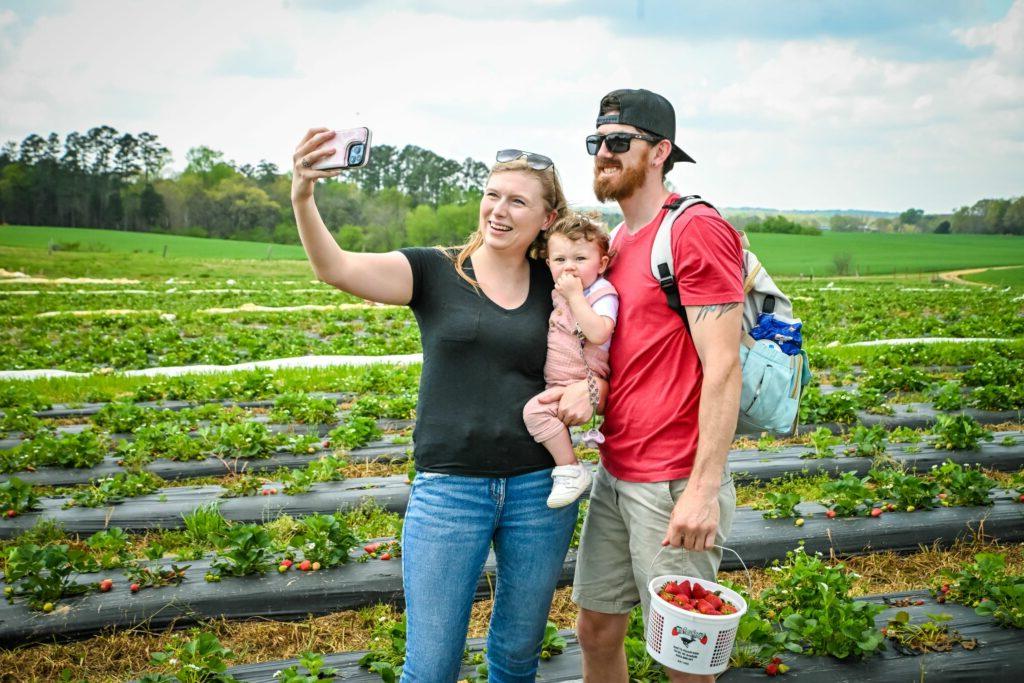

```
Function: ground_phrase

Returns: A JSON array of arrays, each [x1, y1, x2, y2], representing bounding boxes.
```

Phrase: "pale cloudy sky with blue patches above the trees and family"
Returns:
[[0, 0, 1024, 212]]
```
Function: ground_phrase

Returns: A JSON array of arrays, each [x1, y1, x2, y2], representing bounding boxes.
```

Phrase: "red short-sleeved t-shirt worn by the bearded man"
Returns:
[[601, 195, 743, 481]]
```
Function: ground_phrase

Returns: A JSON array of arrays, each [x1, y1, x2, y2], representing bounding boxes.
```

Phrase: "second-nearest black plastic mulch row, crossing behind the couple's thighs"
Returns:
[[0, 500, 1024, 644]]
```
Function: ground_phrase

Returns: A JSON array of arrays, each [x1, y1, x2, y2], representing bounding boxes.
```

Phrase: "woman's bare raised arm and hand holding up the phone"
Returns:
[[292, 128, 413, 305]]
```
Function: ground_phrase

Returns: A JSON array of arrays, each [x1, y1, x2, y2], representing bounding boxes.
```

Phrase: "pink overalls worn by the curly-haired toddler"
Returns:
[[522, 284, 615, 442]]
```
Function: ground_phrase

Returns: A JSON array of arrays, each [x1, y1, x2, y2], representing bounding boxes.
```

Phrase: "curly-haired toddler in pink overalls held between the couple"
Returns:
[[522, 213, 618, 508]]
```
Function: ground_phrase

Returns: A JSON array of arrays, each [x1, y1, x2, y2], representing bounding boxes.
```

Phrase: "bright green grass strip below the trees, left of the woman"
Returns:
[[0, 225, 306, 260]]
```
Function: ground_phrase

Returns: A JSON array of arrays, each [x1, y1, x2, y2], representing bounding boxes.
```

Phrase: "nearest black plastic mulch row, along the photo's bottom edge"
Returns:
[[197, 591, 1024, 683]]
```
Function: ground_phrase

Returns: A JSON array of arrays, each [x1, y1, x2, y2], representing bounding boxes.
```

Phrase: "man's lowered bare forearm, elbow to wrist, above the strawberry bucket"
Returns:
[[687, 357, 742, 496]]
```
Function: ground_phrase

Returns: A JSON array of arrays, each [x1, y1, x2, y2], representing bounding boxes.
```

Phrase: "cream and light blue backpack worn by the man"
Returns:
[[609, 195, 811, 434]]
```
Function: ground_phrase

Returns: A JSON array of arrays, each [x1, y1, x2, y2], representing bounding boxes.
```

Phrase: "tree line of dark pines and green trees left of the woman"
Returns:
[[0, 125, 489, 251]]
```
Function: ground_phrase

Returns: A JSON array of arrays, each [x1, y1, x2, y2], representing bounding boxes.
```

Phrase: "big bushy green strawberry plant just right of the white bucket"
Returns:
[[761, 547, 884, 659]]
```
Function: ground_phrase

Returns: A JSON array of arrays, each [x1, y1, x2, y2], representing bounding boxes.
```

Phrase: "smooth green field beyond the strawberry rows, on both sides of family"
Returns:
[[0, 225, 1024, 284]]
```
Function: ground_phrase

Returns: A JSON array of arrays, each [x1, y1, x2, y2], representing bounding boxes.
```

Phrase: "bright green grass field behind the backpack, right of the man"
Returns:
[[749, 232, 1024, 278]]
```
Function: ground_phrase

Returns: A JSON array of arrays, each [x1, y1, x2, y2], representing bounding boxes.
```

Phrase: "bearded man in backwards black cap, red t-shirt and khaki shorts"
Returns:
[[572, 90, 743, 683]]
